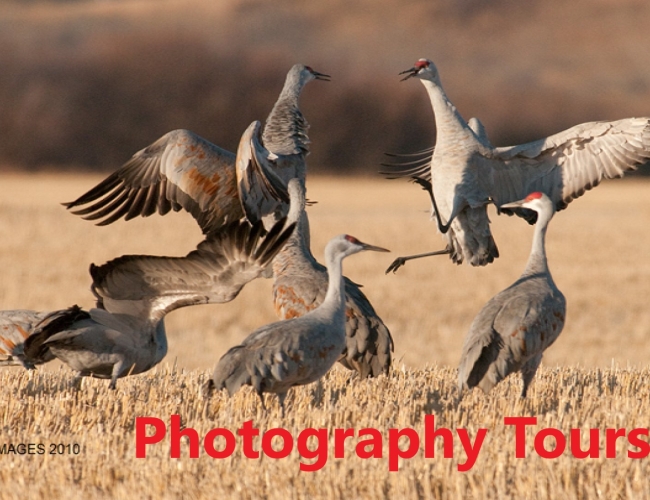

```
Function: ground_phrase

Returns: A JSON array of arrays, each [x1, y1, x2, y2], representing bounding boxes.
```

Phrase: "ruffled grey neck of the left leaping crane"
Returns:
[[262, 79, 309, 155]]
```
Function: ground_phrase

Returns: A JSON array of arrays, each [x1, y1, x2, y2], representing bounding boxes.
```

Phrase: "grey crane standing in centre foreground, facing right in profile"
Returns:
[[204, 234, 388, 414]]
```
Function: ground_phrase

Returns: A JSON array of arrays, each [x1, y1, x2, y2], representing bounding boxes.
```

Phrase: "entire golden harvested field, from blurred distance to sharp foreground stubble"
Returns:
[[0, 174, 650, 498]]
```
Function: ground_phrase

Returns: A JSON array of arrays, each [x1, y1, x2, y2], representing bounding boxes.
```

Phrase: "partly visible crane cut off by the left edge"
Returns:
[[0, 309, 53, 369]]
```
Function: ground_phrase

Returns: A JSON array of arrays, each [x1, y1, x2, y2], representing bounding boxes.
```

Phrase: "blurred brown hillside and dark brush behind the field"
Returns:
[[0, 0, 650, 175]]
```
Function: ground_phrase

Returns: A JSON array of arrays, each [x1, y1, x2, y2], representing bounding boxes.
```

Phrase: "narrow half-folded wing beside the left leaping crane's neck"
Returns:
[[236, 121, 289, 224]]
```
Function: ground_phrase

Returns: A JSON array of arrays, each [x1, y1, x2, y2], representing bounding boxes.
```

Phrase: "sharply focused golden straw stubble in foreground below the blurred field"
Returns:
[[0, 365, 650, 499]]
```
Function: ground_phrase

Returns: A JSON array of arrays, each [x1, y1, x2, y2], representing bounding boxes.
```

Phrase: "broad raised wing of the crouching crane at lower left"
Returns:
[[90, 219, 295, 318]]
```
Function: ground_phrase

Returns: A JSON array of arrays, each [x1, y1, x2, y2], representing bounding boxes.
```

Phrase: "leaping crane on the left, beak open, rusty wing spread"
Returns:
[[64, 64, 329, 234]]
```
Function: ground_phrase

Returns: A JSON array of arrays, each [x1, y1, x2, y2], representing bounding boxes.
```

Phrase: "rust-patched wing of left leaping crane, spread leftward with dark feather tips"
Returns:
[[64, 130, 243, 233]]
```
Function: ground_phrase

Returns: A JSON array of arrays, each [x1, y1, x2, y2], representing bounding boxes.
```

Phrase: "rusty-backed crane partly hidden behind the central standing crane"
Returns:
[[273, 180, 393, 378]]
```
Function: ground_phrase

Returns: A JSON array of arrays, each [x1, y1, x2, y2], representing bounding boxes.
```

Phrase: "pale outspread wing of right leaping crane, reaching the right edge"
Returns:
[[479, 118, 650, 218]]
